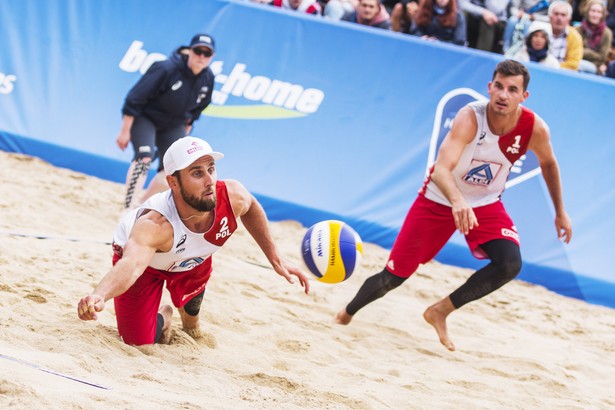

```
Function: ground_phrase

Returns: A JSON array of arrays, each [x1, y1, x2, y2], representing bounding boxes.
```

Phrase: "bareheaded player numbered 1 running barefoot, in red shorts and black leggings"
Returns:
[[335, 60, 572, 350]]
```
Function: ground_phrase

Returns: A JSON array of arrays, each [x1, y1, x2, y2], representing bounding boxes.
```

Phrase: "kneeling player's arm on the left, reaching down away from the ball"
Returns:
[[77, 211, 173, 320]]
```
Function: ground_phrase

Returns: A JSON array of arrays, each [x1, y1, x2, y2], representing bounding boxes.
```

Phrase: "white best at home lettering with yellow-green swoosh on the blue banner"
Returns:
[[119, 40, 325, 120]]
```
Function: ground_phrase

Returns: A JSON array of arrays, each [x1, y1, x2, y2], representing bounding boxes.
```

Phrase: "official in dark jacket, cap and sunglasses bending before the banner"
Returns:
[[116, 34, 215, 209]]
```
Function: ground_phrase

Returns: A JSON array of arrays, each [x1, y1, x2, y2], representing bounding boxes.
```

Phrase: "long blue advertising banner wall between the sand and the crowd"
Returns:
[[0, 0, 615, 307]]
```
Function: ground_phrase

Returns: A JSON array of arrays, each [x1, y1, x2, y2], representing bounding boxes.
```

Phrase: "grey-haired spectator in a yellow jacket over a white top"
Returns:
[[549, 0, 583, 71]]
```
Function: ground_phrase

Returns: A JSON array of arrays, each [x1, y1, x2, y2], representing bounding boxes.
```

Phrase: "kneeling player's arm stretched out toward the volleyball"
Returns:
[[225, 180, 310, 293]]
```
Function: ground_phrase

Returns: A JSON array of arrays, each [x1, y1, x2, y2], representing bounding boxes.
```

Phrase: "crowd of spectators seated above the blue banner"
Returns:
[[246, 0, 615, 78]]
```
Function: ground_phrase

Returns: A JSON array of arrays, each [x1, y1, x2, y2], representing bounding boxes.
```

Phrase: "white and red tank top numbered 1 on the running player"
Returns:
[[419, 101, 535, 208]]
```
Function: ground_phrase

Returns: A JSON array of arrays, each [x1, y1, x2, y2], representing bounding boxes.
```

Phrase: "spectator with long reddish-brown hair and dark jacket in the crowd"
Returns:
[[410, 0, 466, 46]]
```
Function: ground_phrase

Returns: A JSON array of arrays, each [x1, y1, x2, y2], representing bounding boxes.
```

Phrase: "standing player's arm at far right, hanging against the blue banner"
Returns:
[[528, 115, 572, 243]]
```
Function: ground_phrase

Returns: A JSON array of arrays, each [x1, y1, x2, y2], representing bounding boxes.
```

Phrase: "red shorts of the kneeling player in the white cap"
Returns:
[[113, 254, 212, 345]]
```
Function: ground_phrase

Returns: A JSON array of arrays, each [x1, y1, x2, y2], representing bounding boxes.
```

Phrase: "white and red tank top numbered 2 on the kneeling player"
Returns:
[[113, 181, 237, 272]]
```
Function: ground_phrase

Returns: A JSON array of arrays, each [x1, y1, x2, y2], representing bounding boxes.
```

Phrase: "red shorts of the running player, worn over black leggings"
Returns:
[[387, 194, 519, 278]]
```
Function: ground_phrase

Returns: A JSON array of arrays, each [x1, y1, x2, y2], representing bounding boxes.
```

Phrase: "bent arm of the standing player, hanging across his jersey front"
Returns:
[[431, 107, 478, 235]]
